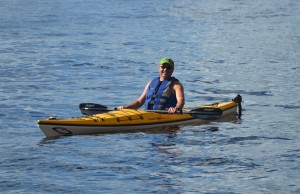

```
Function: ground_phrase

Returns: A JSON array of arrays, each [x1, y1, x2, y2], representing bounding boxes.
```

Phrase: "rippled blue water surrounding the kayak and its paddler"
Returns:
[[0, 0, 300, 194]]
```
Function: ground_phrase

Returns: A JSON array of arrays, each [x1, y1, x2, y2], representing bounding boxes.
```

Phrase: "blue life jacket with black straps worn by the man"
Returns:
[[144, 77, 178, 110]]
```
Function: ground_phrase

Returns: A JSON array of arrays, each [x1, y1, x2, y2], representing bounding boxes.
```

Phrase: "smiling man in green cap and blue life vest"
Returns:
[[117, 57, 185, 113]]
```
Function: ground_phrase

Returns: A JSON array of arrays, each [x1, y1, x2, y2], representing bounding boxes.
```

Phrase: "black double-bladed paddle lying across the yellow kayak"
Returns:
[[79, 103, 223, 119]]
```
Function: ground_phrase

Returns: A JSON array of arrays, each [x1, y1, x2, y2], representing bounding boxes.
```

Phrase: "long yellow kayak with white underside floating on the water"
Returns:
[[38, 96, 241, 137]]
